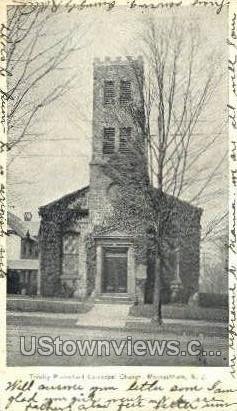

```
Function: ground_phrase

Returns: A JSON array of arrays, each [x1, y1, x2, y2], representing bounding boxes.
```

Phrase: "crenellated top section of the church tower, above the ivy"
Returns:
[[92, 56, 144, 162]]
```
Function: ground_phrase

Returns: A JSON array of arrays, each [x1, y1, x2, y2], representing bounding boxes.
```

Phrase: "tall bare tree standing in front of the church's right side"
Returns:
[[104, 19, 227, 321]]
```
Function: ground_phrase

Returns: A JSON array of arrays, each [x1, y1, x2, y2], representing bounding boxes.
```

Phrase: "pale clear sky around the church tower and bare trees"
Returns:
[[8, 7, 228, 260]]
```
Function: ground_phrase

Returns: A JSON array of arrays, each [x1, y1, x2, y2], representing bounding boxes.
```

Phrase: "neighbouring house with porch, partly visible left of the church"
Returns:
[[7, 212, 39, 295]]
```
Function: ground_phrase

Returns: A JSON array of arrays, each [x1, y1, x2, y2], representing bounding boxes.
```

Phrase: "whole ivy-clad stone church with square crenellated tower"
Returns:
[[39, 58, 201, 303]]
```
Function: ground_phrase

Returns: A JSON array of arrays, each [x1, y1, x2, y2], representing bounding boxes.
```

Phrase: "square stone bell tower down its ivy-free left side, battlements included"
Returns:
[[89, 57, 145, 224]]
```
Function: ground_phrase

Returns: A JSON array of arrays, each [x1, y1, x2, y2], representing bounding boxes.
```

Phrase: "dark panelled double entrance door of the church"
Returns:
[[102, 247, 128, 293]]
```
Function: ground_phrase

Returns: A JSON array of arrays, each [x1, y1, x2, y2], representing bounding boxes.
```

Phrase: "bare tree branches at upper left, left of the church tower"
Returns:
[[6, 5, 84, 167]]
